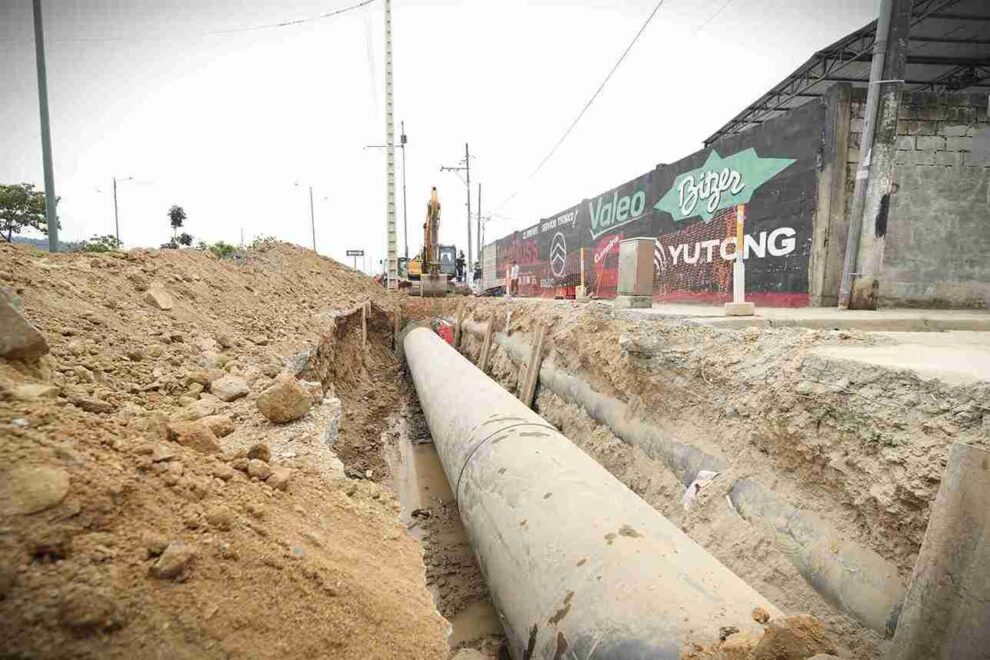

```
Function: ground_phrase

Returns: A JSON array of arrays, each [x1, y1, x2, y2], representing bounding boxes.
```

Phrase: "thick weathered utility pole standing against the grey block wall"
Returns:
[[839, 0, 913, 309]]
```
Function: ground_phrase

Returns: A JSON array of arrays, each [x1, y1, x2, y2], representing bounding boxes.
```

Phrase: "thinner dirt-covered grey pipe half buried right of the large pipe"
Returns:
[[464, 322, 905, 637]]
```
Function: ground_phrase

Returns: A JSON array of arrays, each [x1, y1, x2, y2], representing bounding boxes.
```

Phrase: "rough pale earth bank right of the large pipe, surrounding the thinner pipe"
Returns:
[[444, 300, 990, 658]]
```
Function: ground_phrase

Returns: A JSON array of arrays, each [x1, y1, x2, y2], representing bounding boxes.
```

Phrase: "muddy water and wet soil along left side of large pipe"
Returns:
[[385, 385, 502, 656]]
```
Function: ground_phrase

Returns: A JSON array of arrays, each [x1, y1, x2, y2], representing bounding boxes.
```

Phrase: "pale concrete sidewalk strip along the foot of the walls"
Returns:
[[615, 304, 990, 332]]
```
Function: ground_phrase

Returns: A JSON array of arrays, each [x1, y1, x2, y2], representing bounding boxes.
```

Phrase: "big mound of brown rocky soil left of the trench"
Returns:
[[0, 245, 447, 658]]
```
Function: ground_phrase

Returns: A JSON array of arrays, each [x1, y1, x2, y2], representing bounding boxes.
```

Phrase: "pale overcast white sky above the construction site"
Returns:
[[0, 0, 876, 267]]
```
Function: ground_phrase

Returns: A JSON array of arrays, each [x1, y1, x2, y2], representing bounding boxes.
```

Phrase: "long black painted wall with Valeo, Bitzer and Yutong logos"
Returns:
[[485, 103, 824, 306]]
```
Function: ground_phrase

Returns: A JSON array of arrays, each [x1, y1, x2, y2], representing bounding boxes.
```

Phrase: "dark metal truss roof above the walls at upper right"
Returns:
[[705, 0, 990, 147]]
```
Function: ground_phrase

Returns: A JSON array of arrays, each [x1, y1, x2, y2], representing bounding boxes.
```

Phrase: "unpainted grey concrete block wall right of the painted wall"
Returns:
[[840, 89, 990, 308]]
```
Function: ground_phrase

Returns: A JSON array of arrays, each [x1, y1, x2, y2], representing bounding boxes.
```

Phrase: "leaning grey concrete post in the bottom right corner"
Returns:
[[887, 443, 990, 660]]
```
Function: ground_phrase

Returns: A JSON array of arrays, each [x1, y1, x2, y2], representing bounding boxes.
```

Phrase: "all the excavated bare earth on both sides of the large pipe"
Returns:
[[0, 243, 990, 658]]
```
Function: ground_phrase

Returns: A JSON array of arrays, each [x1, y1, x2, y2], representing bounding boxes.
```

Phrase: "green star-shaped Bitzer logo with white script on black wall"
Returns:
[[653, 148, 795, 222]]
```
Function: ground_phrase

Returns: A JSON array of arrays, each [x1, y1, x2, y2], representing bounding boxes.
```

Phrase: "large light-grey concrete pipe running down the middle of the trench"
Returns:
[[404, 328, 781, 660]]
